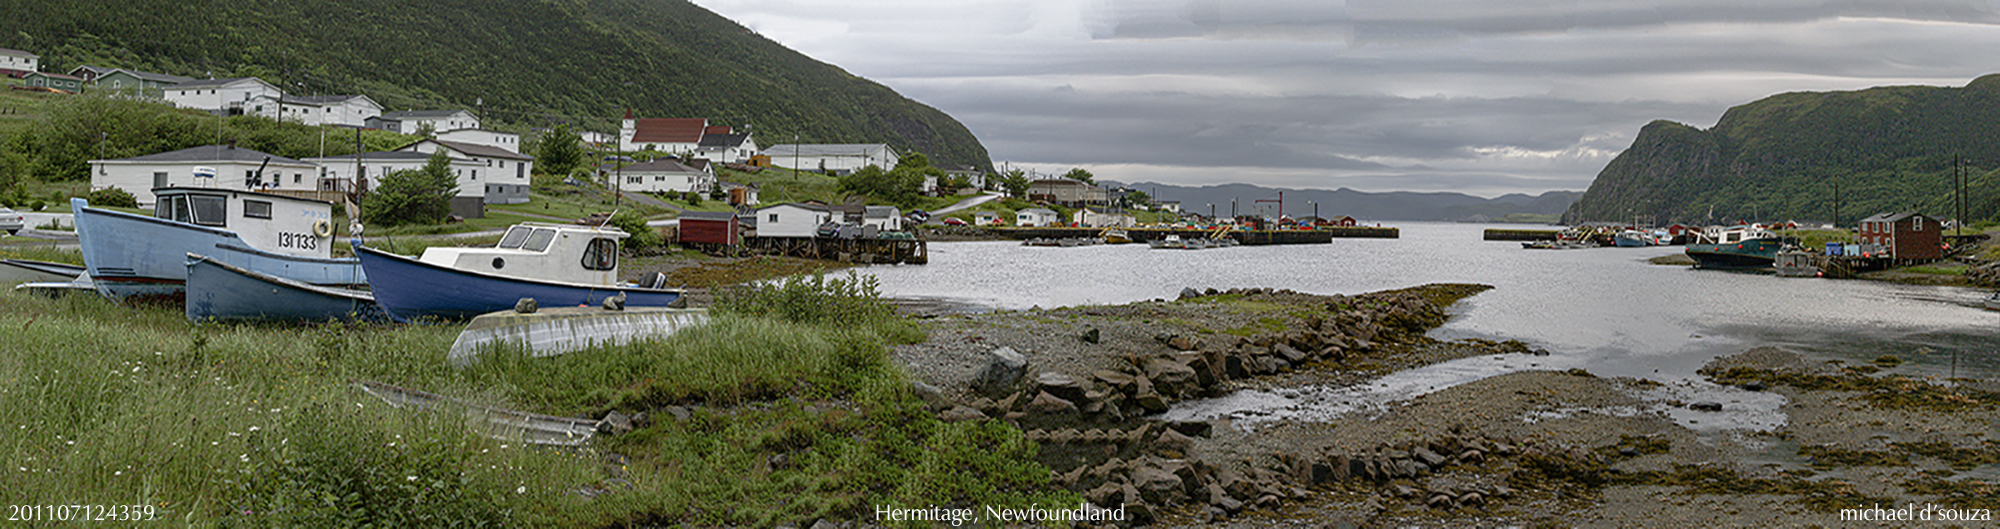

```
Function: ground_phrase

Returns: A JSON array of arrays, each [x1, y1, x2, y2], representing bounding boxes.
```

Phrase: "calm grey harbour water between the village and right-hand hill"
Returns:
[[866, 222, 2000, 432]]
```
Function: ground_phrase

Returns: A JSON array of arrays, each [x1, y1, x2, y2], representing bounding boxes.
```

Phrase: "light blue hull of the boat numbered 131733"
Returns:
[[72, 198, 368, 301]]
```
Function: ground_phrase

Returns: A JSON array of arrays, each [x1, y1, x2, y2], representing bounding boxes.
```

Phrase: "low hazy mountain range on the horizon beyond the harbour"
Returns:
[[1104, 182, 1582, 220]]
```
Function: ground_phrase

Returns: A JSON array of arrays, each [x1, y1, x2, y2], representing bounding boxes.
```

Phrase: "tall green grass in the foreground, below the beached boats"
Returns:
[[0, 270, 1078, 527]]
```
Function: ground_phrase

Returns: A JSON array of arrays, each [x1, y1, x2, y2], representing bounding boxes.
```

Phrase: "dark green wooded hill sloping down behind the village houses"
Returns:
[[0, 0, 990, 166]]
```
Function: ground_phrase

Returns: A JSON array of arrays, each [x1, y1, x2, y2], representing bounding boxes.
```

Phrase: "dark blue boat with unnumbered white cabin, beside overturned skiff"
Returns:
[[354, 222, 680, 321]]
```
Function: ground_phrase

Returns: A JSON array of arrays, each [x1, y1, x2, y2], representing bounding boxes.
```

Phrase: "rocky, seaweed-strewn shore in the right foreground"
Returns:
[[892, 285, 2000, 527]]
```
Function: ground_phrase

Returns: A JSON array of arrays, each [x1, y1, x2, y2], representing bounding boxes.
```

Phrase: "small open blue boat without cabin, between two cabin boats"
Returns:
[[184, 254, 388, 323]]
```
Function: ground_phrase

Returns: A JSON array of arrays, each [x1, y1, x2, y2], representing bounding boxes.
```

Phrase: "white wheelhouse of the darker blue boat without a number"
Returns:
[[418, 222, 628, 287]]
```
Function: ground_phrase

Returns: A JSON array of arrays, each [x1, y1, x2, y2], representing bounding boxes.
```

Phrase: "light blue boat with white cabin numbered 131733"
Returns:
[[70, 186, 368, 301]]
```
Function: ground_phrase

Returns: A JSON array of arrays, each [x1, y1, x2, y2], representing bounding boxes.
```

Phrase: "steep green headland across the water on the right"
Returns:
[[1562, 74, 2000, 226]]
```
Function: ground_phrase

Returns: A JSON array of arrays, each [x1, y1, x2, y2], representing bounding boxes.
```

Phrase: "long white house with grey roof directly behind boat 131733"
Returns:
[[90, 144, 320, 206]]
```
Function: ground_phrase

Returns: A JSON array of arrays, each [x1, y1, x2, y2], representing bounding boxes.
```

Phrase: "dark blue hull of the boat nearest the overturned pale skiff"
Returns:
[[354, 244, 680, 321]]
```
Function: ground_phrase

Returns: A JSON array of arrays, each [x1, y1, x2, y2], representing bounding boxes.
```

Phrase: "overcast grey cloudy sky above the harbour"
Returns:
[[694, 0, 2000, 196]]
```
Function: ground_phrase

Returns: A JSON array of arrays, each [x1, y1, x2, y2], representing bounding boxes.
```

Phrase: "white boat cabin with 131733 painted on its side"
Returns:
[[152, 186, 334, 258]]
